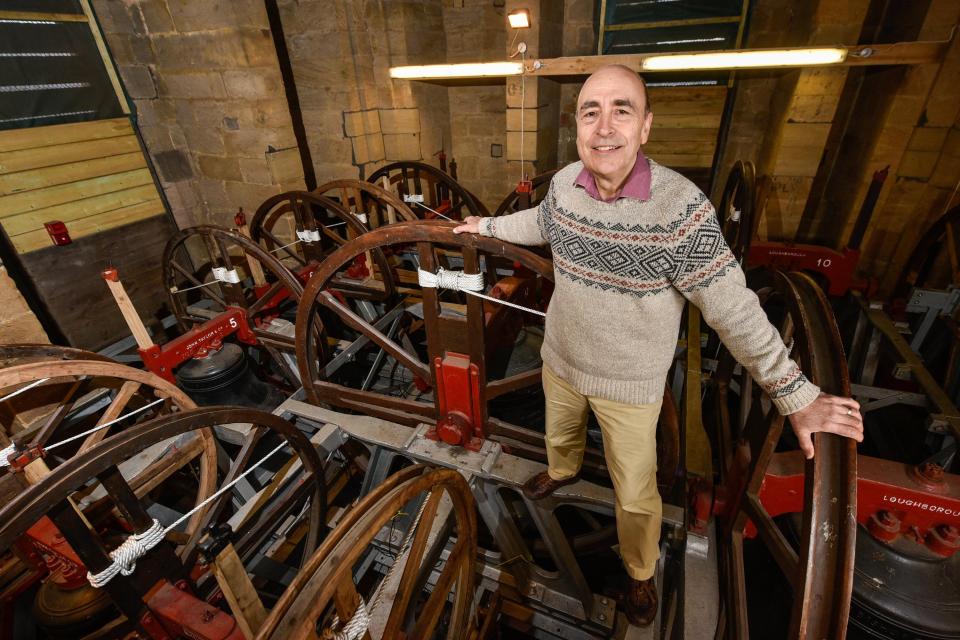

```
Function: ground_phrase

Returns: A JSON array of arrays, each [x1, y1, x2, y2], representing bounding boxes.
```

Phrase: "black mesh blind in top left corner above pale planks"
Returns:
[[0, 0, 123, 129]]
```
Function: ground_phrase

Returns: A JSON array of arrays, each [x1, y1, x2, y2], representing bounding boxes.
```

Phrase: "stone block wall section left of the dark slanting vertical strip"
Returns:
[[93, 0, 303, 227]]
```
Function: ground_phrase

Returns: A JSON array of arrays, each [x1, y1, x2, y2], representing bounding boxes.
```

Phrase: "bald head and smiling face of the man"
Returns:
[[577, 67, 653, 186]]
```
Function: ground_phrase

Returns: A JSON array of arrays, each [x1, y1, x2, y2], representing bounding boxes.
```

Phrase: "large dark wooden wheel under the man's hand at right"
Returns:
[[714, 271, 857, 639]]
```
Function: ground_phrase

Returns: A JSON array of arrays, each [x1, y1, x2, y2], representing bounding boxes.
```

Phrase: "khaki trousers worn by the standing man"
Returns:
[[543, 365, 663, 580]]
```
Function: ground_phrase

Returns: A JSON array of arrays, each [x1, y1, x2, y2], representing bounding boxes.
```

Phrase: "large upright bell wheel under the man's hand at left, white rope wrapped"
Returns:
[[297, 221, 553, 431]]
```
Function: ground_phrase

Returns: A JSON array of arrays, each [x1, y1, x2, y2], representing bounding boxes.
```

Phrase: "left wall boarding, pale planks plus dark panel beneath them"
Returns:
[[0, 118, 176, 350]]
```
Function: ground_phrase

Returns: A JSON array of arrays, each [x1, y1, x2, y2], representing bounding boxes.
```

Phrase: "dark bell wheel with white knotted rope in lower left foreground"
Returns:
[[0, 407, 327, 637]]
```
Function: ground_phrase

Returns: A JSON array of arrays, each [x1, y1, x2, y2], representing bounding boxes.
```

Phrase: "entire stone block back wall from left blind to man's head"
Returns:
[[93, 0, 576, 222]]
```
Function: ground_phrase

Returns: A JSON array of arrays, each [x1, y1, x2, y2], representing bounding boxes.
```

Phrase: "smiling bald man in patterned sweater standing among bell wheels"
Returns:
[[455, 65, 863, 625]]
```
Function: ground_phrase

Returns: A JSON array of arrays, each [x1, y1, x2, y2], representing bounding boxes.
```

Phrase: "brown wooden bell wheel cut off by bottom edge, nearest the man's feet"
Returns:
[[257, 465, 477, 640]]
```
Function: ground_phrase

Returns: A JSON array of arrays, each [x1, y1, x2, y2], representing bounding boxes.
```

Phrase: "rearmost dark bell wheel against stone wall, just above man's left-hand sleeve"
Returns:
[[367, 161, 487, 220]]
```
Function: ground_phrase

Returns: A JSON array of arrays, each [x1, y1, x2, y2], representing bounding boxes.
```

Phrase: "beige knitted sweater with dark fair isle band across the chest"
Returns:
[[480, 161, 820, 415]]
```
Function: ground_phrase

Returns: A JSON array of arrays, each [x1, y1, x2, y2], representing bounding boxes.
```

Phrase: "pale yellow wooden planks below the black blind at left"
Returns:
[[0, 118, 164, 254]]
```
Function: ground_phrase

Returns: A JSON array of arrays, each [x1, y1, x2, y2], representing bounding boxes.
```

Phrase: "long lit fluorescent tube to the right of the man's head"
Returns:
[[641, 47, 847, 71]]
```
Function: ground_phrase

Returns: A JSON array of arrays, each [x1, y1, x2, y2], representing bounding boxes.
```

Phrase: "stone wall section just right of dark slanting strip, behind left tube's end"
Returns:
[[280, 0, 450, 183]]
